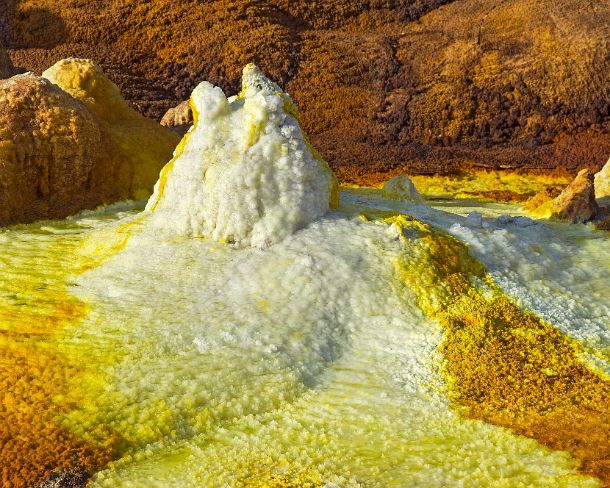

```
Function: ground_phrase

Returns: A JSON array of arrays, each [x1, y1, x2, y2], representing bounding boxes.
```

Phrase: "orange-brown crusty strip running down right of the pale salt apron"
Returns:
[[384, 214, 610, 487]]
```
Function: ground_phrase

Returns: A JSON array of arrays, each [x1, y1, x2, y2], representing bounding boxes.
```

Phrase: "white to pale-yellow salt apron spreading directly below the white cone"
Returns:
[[57, 199, 600, 486]]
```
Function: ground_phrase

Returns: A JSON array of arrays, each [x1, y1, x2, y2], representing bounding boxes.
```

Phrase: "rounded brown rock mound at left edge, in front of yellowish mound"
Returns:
[[0, 74, 102, 224]]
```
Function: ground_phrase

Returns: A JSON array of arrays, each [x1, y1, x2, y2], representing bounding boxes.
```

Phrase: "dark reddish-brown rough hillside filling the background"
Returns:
[[0, 0, 610, 184]]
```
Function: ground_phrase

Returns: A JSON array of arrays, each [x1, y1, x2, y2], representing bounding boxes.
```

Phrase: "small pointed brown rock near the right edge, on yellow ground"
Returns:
[[550, 169, 598, 222]]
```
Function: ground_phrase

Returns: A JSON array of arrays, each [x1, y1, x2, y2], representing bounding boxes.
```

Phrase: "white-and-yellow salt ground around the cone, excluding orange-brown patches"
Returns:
[[0, 192, 608, 487]]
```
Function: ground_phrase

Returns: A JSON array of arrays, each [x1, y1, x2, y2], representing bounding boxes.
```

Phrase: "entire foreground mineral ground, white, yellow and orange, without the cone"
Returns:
[[0, 193, 610, 487]]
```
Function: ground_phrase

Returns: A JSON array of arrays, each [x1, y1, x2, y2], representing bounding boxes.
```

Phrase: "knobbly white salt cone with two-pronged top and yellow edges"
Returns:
[[146, 64, 338, 247]]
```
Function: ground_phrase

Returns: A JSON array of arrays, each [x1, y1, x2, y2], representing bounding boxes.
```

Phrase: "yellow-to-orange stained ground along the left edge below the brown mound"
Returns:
[[0, 231, 112, 487]]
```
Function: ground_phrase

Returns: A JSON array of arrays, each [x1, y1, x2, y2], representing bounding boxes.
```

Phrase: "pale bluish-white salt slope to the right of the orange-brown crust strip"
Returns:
[[344, 192, 610, 374]]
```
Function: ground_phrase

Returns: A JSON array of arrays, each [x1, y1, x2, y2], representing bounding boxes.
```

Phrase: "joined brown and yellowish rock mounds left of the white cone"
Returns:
[[0, 60, 179, 225]]
